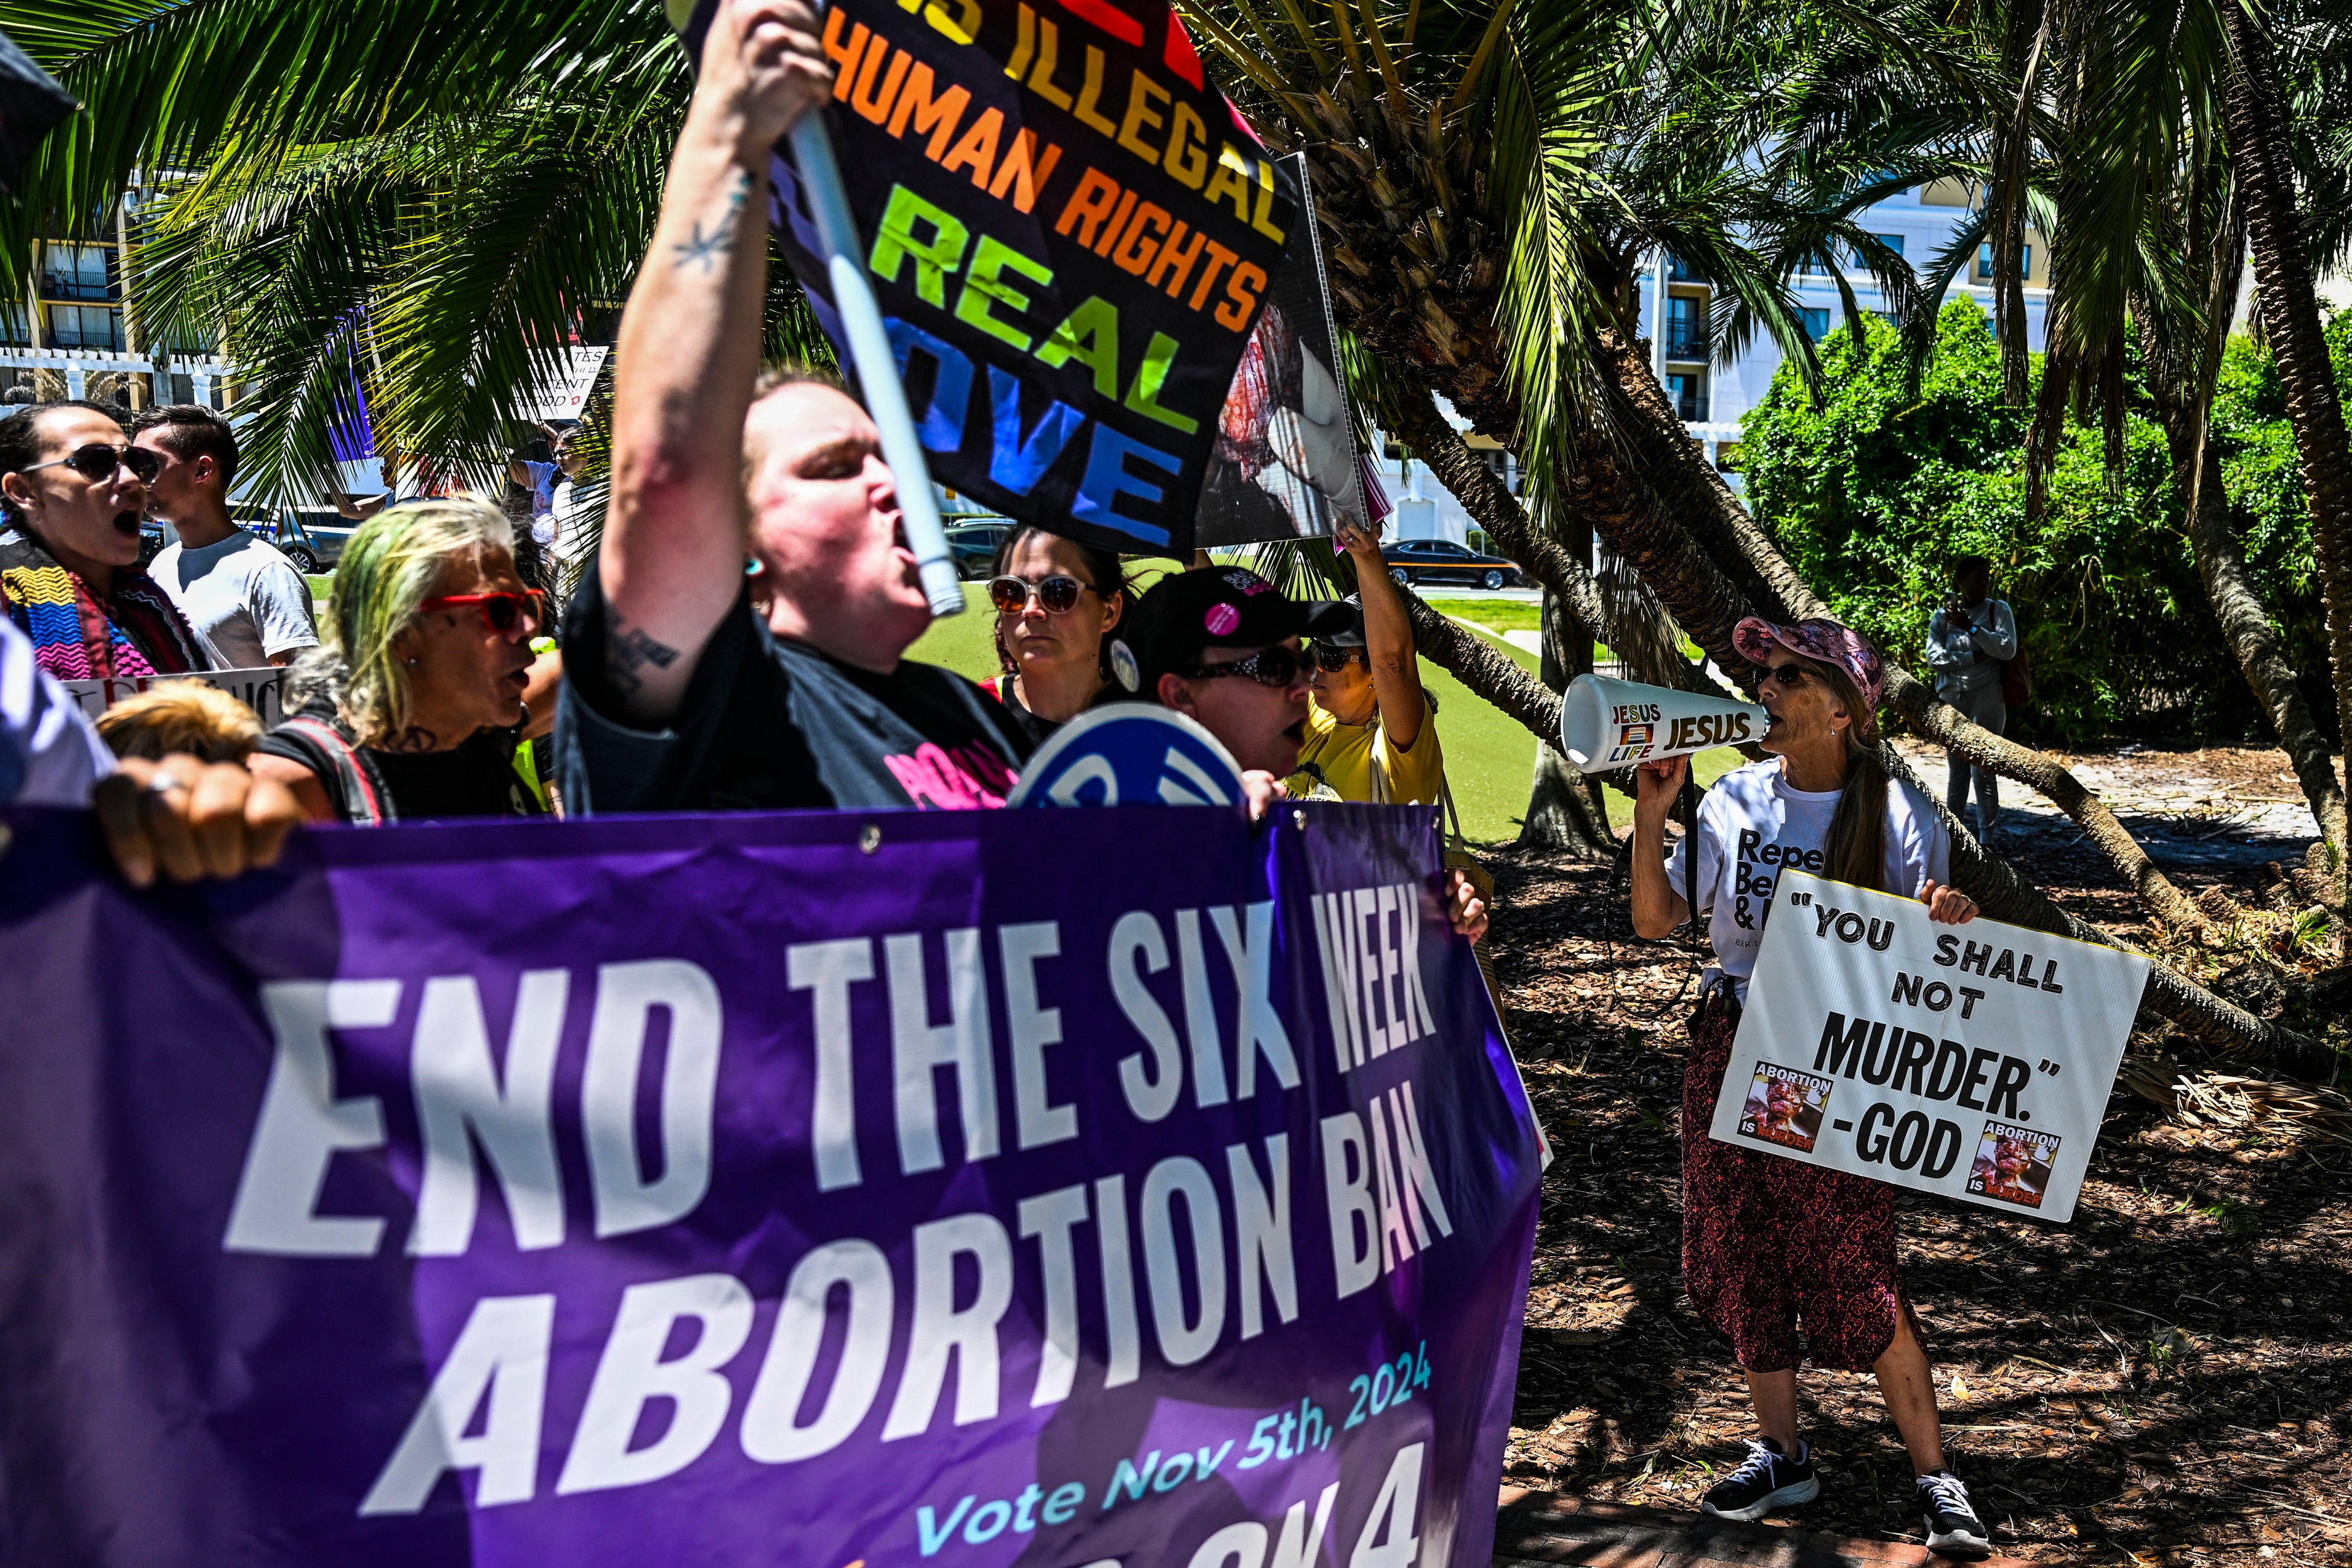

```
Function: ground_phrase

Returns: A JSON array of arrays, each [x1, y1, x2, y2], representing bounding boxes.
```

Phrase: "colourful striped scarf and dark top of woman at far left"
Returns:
[[0, 529, 209, 680]]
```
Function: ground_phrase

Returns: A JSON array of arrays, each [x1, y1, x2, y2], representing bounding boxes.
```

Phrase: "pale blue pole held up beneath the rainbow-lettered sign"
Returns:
[[792, 83, 964, 616]]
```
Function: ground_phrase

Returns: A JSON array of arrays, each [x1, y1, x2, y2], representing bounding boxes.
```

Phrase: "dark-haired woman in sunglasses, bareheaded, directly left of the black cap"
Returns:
[[981, 524, 1134, 743]]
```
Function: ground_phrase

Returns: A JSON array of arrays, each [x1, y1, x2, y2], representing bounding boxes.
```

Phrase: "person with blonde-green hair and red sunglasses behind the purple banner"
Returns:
[[251, 496, 557, 825]]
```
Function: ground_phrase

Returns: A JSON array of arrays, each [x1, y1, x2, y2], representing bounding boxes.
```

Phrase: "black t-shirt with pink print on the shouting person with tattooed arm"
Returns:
[[555, 571, 1032, 816]]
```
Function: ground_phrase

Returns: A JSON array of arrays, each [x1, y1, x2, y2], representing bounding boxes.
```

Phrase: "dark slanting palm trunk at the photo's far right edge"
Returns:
[[2221, 5, 2352, 908]]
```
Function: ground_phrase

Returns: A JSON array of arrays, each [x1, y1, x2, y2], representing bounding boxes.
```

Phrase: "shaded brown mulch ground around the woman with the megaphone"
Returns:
[[1489, 823, 2352, 1568]]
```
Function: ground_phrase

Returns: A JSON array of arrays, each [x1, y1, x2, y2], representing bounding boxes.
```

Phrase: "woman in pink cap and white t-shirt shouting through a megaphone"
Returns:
[[1633, 618, 1992, 1558]]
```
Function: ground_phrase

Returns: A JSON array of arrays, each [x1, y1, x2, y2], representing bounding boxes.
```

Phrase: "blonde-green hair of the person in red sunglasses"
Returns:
[[303, 496, 515, 745]]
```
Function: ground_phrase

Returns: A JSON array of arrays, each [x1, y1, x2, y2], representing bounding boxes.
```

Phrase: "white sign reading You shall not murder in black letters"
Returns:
[[1707, 870, 2148, 1222]]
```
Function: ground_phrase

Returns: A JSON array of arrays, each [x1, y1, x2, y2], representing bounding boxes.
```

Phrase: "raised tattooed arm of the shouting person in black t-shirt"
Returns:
[[598, 0, 833, 724]]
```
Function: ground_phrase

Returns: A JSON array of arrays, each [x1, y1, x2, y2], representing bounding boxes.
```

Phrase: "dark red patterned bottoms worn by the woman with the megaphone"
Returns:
[[1682, 987, 1926, 1373]]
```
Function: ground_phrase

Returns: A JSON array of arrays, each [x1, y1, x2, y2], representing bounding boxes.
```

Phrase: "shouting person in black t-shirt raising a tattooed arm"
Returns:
[[557, 0, 1030, 811]]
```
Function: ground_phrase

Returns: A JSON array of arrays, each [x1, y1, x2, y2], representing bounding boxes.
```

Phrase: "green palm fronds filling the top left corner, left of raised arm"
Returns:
[[0, 0, 830, 496]]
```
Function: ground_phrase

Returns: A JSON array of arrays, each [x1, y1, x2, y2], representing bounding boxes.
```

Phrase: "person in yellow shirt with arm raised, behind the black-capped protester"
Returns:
[[1289, 522, 1447, 806]]
